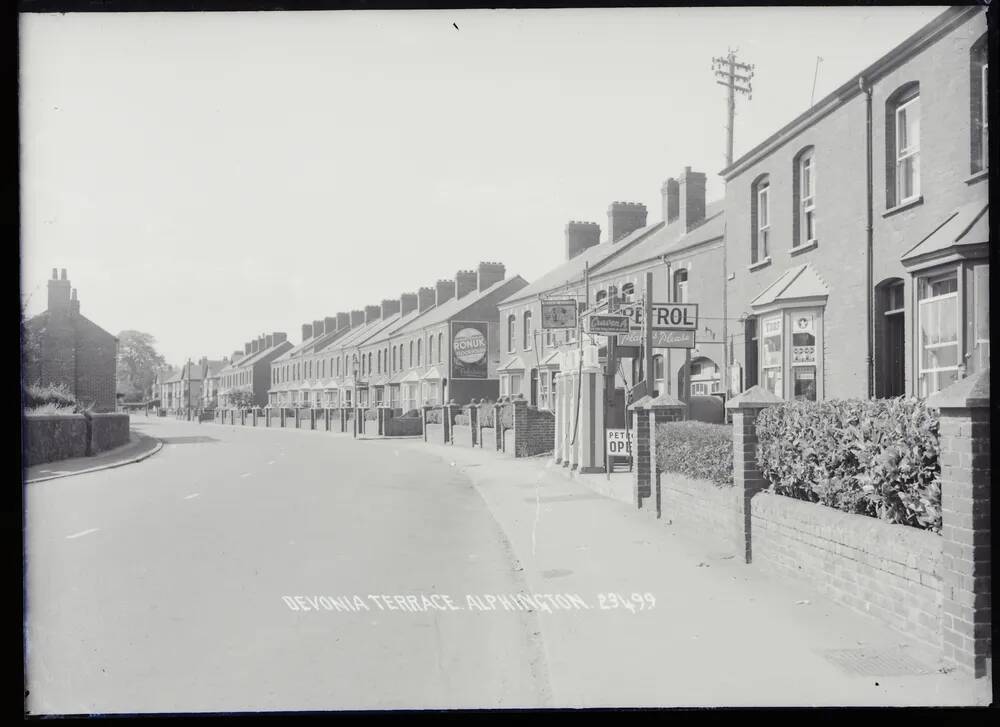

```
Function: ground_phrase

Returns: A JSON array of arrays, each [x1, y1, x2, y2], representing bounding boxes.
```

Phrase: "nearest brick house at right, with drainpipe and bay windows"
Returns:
[[721, 7, 989, 399]]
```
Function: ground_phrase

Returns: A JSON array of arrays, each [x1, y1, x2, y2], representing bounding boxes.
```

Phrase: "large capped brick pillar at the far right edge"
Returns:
[[927, 368, 993, 678]]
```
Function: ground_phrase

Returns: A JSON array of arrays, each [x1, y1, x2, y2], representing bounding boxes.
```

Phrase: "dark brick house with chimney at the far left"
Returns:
[[24, 268, 118, 412]]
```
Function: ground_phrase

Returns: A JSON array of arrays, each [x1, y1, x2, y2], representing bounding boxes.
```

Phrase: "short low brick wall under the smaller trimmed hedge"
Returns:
[[654, 472, 738, 543]]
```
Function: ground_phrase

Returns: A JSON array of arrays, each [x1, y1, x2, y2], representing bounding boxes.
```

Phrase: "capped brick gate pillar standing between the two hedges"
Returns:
[[726, 384, 783, 563]]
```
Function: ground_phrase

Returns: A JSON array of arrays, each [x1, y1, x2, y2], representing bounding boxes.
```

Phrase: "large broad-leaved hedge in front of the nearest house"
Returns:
[[757, 397, 941, 532]]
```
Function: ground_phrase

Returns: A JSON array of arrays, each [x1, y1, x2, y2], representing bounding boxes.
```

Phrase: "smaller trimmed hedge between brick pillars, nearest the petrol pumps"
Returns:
[[656, 421, 733, 487]]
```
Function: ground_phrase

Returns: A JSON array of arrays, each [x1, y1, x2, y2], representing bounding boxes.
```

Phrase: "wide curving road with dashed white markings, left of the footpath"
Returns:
[[26, 418, 548, 713]]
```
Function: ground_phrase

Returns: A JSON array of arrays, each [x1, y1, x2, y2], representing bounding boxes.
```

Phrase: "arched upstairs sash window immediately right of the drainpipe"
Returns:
[[885, 83, 920, 208]]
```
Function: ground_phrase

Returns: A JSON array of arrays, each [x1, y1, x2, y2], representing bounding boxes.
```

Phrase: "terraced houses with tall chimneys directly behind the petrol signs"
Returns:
[[500, 176, 725, 426]]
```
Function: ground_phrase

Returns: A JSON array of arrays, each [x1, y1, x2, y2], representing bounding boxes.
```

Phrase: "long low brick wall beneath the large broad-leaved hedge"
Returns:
[[750, 492, 943, 647]]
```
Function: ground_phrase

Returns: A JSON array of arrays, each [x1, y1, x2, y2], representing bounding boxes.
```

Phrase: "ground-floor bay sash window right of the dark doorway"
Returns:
[[917, 271, 960, 396]]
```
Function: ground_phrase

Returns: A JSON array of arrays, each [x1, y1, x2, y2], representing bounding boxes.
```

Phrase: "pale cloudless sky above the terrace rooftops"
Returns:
[[20, 6, 944, 364]]
